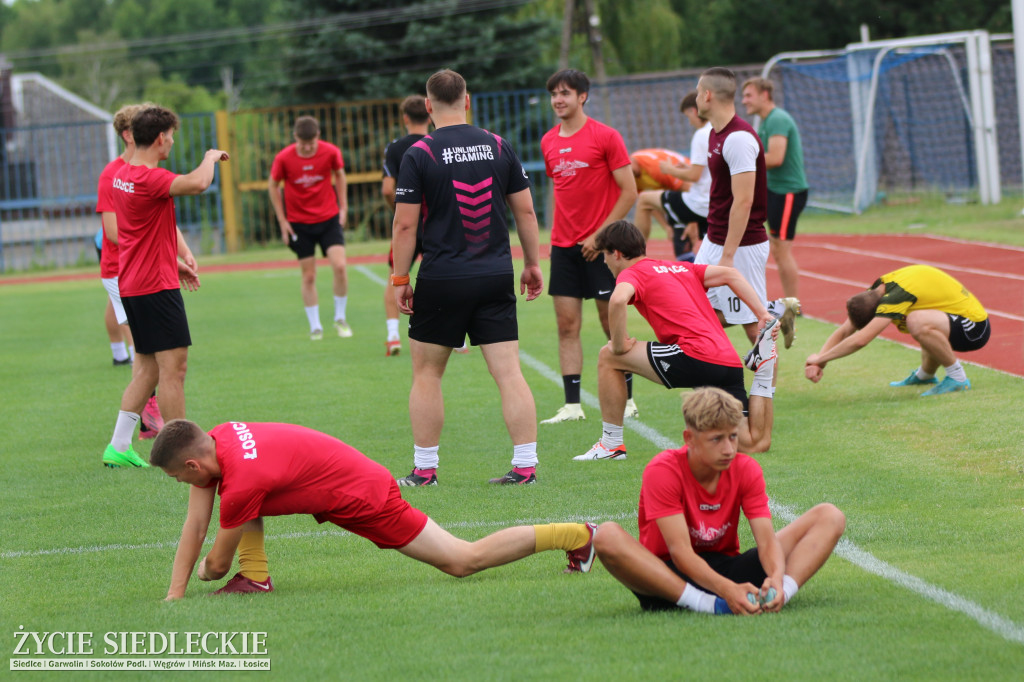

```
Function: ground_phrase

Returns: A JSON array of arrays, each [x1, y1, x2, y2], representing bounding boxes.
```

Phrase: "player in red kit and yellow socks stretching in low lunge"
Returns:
[[150, 420, 594, 600]]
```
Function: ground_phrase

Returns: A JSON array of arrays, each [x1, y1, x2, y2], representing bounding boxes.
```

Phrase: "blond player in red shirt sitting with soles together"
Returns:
[[589, 388, 846, 615]]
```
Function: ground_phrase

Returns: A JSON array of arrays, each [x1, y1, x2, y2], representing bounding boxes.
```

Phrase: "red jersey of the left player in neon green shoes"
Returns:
[[113, 164, 179, 297]]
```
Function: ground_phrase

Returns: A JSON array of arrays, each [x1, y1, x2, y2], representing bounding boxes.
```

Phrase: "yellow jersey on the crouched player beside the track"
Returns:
[[871, 265, 988, 334]]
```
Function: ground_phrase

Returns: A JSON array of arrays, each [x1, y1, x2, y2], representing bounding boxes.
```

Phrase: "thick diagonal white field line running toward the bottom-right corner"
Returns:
[[519, 350, 1024, 644]]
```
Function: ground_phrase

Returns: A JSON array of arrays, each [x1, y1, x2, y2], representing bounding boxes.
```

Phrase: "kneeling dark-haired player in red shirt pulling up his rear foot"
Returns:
[[572, 220, 778, 461]]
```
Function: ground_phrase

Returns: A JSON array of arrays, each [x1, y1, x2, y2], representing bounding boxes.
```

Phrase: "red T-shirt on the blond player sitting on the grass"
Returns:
[[638, 445, 771, 559]]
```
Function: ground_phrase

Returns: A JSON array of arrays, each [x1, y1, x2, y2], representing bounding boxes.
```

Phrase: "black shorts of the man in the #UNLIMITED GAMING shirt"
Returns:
[[409, 272, 519, 348]]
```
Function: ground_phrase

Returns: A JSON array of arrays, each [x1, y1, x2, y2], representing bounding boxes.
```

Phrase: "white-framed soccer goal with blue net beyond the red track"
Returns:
[[762, 31, 1000, 213]]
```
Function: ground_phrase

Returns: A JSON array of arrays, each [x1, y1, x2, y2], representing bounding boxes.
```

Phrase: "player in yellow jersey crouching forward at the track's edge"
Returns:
[[804, 265, 991, 396]]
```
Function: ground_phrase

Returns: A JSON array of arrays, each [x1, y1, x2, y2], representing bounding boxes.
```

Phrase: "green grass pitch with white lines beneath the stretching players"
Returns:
[[0, 214, 1024, 680]]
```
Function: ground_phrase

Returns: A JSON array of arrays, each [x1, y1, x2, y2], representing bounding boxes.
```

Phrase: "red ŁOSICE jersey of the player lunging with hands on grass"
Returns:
[[210, 422, 393, 528]]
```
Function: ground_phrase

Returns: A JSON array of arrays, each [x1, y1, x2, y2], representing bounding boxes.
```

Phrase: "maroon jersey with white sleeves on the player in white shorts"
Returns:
[[708, 116, 768, 246]]
